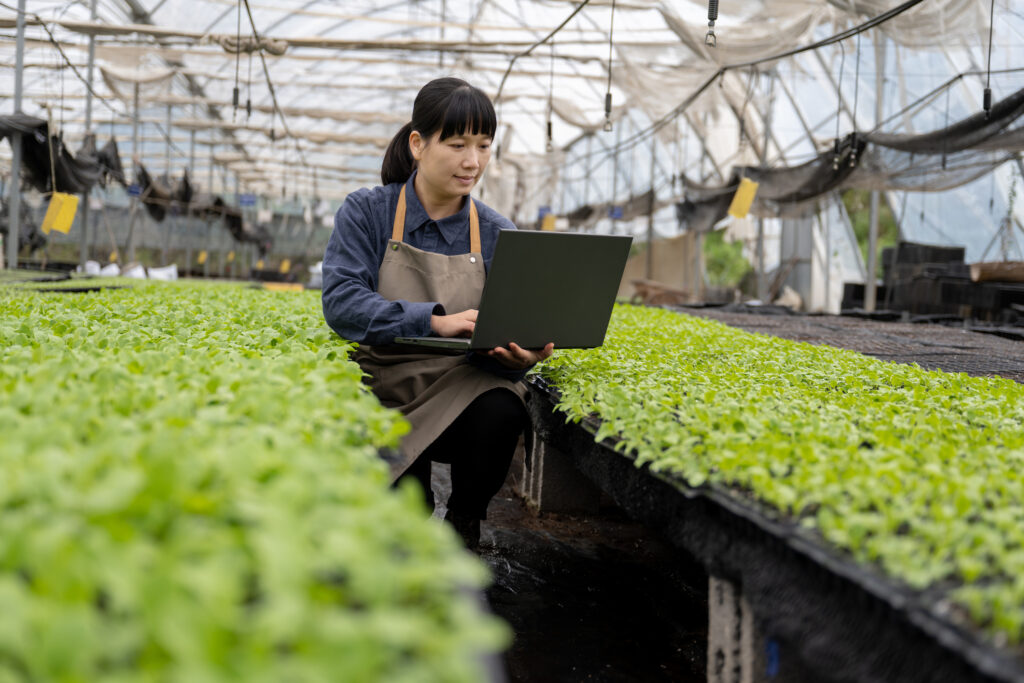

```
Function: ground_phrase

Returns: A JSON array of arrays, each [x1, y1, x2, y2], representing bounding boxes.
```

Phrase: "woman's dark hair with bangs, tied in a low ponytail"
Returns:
[[381, 78, 498, 185]]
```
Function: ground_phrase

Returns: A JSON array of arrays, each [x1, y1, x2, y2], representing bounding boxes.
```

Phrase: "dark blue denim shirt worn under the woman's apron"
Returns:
[[323, 173, 525, 380]]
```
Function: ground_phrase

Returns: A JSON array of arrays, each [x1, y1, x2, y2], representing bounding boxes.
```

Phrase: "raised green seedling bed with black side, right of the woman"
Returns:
[[535, 306, 1024, 680]]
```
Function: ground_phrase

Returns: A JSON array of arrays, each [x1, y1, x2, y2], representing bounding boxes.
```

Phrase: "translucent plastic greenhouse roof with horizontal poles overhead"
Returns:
[[0, 0, 1024, 264]]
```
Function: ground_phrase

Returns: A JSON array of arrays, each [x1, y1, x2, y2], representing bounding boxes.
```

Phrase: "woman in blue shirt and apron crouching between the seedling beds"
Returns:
[[323, 78, 553, 548]]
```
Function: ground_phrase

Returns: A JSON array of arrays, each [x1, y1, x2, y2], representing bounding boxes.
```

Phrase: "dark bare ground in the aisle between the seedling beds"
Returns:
[[433, 463, 708, 683]]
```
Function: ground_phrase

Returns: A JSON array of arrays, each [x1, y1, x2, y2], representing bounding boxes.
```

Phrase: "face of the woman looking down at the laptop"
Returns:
[[409, 130, 492, 200]]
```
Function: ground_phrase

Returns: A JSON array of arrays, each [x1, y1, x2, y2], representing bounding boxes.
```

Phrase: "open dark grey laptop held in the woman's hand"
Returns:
[[394, 230, 633, 350]]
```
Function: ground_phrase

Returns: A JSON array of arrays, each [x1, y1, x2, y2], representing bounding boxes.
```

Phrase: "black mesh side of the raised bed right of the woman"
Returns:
[[527, 376, 1024, 683]]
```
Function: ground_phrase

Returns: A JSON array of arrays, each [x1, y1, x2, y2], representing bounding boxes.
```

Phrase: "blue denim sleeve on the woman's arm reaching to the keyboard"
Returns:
[[322, 189, 443, 345]]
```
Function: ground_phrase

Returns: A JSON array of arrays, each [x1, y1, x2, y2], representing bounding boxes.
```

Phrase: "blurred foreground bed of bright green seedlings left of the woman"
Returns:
[[0, 283, 508, 682]]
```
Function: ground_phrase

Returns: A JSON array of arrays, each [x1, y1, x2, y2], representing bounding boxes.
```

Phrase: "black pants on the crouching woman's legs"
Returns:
[[395, 389, 529, 519]]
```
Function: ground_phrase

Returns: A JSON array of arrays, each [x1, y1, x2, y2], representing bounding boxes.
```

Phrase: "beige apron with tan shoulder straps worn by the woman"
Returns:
[[354, 187, 526, 481]]
